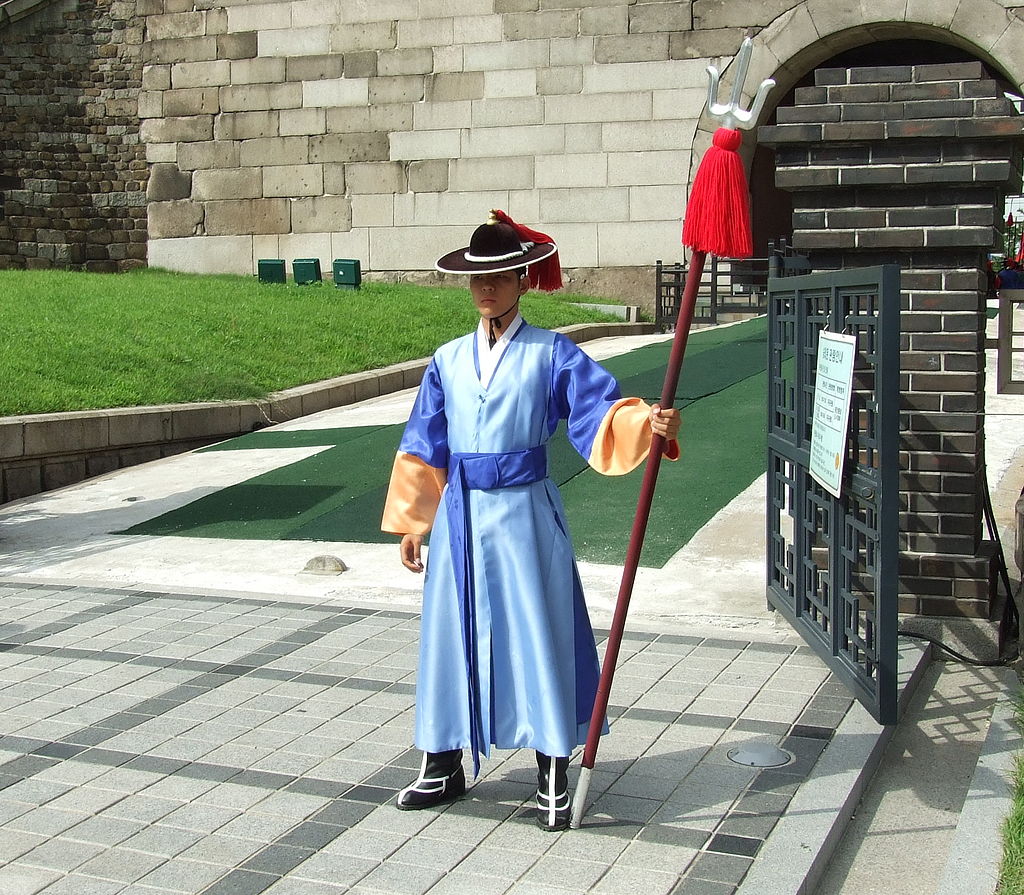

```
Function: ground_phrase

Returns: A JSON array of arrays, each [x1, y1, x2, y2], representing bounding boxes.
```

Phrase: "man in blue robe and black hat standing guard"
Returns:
[[382, 212, 679, 830]]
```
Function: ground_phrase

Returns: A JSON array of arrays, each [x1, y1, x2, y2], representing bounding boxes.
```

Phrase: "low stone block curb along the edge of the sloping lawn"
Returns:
[[0, 323, 655, 502]]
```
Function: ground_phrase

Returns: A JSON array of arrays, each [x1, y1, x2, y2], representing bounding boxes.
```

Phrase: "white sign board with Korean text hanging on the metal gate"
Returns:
[[808, 332, 857, 497]]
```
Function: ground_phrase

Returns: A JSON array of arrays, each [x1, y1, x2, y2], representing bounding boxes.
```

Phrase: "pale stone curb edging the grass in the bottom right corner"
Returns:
[[935, 669, 1024, 895]]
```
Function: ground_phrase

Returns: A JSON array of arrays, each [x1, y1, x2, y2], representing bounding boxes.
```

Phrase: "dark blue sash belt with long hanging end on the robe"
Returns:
[[444, 444, 548, 776]]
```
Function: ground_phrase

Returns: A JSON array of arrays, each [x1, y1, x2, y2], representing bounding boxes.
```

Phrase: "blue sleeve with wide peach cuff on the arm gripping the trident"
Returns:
[[552, 336, 679, 475]]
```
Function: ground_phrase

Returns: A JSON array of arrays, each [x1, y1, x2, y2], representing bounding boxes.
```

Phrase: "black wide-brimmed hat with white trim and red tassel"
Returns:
[[436, 209, 562, 291]]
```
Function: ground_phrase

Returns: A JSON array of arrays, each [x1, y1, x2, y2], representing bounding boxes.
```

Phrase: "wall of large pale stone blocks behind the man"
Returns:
[[139, 0, 743, 286]]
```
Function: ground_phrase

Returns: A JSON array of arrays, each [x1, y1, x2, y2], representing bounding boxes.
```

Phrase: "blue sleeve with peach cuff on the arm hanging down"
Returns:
[[381, 361, 449, 535]]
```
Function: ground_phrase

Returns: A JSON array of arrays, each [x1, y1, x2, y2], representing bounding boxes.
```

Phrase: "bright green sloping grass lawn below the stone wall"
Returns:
[[0, 269, 613, 416]]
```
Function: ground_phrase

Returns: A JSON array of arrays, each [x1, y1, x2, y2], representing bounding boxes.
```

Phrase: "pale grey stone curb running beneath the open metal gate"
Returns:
[[736, 643, 930, 895]]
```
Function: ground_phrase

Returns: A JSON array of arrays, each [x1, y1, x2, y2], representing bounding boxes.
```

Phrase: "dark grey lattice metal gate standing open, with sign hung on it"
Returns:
[[767, 264, 900, 724]]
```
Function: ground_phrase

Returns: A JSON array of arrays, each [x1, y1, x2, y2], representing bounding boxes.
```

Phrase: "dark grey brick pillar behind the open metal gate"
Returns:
[[759, 62, 1024, 617]]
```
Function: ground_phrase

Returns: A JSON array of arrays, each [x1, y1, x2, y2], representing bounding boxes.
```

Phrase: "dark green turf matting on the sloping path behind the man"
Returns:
[[124, 318, 766, 566]]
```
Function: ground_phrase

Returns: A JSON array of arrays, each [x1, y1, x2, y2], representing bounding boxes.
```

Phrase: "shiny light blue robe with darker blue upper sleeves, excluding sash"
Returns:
[[385, 323, 663, 767]]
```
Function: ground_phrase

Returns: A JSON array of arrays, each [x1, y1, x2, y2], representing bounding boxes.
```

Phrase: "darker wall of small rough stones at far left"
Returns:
[[0, 0, 148, 271]]
